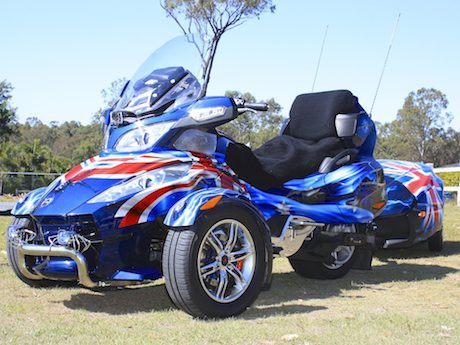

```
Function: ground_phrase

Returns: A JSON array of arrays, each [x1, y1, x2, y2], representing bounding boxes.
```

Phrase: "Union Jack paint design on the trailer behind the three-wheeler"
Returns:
[[379, 160, 444, 239]]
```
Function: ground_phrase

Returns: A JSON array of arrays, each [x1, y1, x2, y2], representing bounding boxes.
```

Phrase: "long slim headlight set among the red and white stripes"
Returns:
[[88, 164, 191, 204]]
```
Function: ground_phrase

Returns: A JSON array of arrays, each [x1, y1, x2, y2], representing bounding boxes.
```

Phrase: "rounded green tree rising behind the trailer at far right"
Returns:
[[394, 88, 452, 162]]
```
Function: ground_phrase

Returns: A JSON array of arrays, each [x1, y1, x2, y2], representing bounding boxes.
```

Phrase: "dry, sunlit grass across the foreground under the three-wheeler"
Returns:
[[0, 205, 460, 345]]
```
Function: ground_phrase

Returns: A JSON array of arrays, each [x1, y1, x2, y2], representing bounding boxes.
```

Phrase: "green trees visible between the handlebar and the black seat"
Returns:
[[219, 91, 283, 148]]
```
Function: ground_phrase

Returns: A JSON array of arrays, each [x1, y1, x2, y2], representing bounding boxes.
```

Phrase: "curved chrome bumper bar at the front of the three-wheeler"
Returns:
[[16, 244, 106, 288]]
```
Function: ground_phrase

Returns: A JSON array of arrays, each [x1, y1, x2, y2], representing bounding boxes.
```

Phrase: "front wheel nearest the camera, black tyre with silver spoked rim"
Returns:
[[163, 205, 267, 318]]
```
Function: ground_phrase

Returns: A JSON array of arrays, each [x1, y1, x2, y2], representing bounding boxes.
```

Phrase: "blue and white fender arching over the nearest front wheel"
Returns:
[[164, 188, 250, 227]]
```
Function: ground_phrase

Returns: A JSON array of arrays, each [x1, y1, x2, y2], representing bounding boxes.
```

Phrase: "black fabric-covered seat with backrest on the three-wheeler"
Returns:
[[226, 90, 359, 189]]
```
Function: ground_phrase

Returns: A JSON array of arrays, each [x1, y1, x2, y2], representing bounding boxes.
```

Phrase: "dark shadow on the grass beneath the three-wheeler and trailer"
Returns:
[[64, 255, 457, 319]]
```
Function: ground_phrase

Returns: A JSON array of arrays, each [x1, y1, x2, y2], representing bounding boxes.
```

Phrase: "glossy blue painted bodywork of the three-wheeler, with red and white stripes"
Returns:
[[9, 92, 386, 281]]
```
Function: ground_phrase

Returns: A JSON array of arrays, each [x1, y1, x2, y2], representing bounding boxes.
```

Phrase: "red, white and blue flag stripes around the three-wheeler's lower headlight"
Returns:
[[82, 151, 247, 227]]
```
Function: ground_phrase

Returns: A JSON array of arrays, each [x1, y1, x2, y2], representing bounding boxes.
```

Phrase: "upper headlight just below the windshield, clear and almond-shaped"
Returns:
[[113, 121, 175, 152]]
